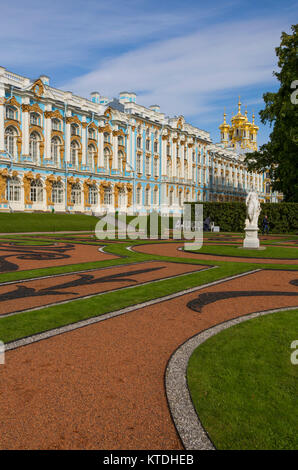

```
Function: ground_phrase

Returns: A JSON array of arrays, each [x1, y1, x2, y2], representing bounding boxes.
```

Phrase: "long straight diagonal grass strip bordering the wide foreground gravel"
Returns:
[[0, 259, 253, 343]]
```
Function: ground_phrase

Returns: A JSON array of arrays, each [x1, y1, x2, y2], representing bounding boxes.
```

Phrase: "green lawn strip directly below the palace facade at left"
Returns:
[[0, 212, 98, 233]]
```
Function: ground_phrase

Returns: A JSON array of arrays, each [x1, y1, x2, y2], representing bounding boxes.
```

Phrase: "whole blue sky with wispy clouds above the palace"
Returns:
[[0, 0, 298, 144]]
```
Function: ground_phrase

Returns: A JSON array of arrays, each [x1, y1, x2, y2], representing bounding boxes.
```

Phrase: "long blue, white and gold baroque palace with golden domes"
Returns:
[[0, 67, 280, 214]]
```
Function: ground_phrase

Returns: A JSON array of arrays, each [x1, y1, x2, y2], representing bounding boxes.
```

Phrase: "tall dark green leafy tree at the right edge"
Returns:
[[245, 24, 298, 202]]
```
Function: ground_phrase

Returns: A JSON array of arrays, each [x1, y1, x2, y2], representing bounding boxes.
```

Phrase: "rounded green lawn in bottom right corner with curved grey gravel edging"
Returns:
[[187, 309, 298, 450]]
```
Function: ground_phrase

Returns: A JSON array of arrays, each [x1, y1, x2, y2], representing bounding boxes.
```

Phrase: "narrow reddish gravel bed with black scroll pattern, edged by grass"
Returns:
[[0, 261, 206, 315]]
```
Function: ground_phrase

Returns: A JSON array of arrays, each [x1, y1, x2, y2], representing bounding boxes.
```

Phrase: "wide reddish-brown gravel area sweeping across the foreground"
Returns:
[[0, 270, 298, 450]]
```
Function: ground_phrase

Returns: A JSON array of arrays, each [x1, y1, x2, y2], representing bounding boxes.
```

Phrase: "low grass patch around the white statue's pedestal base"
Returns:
[[190, 245, 298, 259]]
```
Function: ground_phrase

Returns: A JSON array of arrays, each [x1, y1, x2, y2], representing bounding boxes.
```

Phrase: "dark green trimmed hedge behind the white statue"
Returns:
[[190, 202, 298, 233]]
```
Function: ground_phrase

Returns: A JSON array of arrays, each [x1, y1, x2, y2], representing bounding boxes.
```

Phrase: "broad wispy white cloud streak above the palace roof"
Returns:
[[64, 19, 286, 116]]
